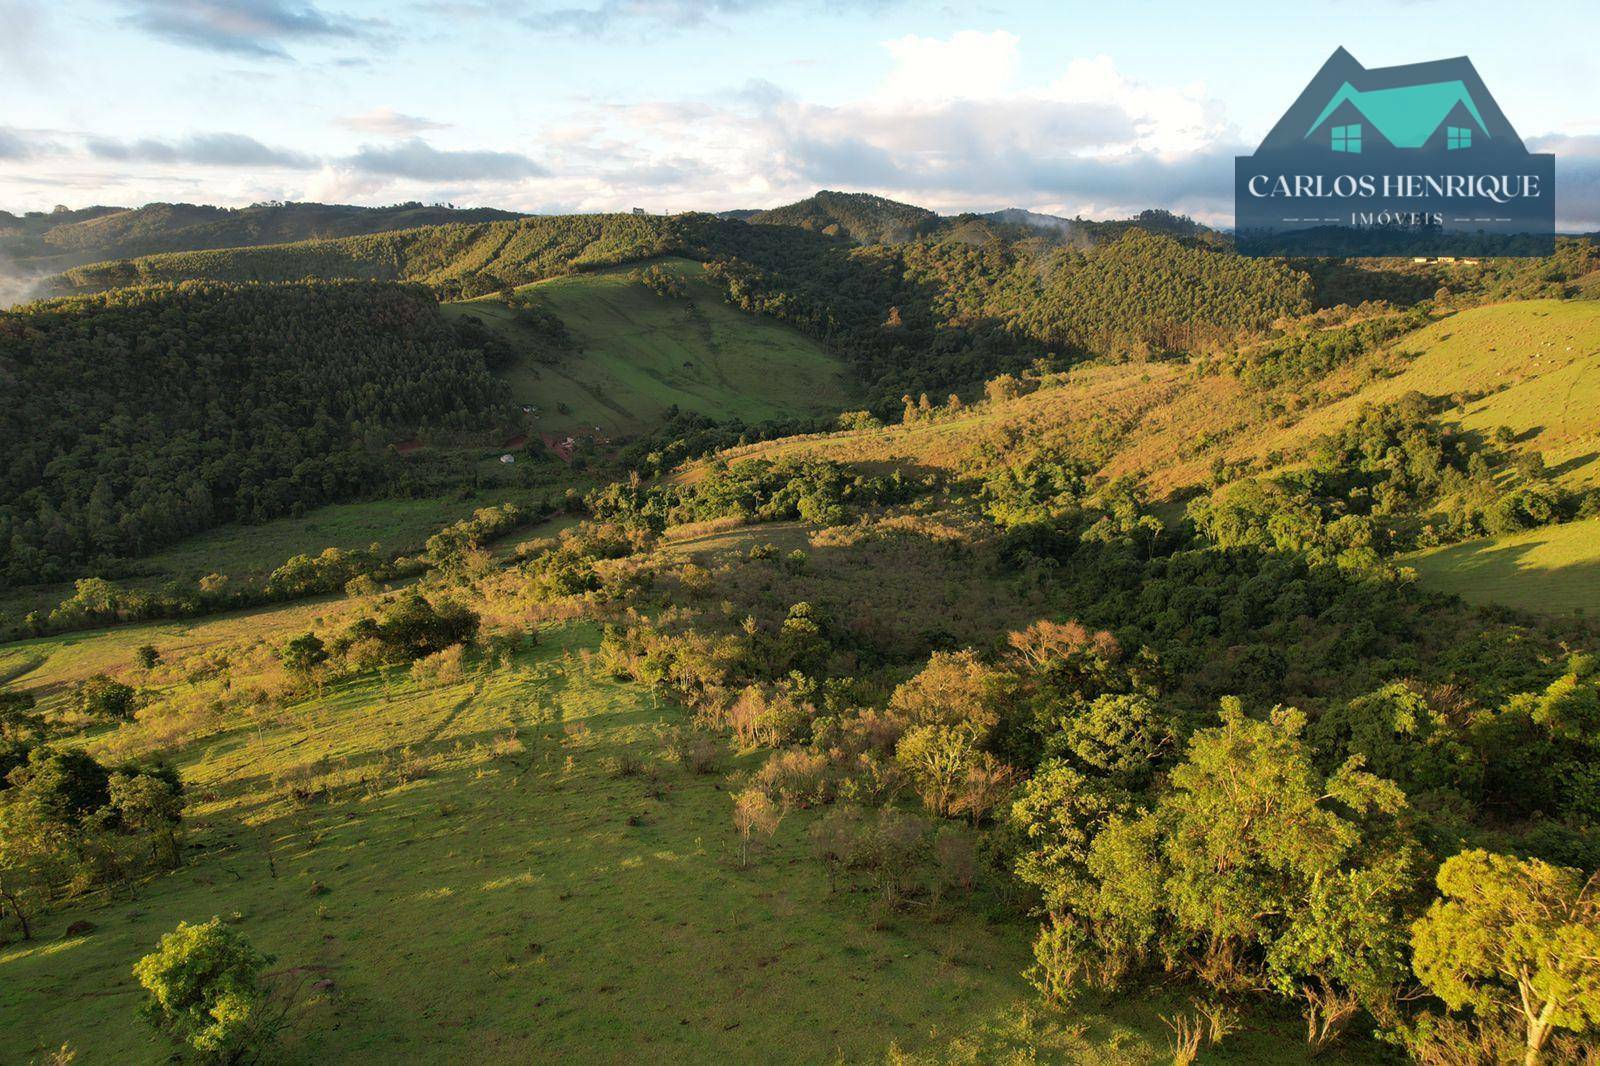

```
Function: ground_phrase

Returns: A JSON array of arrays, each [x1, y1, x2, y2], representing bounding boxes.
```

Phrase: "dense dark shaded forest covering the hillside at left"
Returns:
[[0, 282, 504, 586]]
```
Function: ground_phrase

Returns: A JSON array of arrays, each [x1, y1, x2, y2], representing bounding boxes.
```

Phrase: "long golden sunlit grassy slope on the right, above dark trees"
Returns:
[[678, 299, 1600, 499]]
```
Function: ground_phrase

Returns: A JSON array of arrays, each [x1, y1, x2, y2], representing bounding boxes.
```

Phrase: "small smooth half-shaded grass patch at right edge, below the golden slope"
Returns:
[[1402, 519, 1600, 616]]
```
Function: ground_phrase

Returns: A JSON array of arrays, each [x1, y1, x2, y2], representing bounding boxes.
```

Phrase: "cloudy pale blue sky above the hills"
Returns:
[[0, 0, 1600, 230]]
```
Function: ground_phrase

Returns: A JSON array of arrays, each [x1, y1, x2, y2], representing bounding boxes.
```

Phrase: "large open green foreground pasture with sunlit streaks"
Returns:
[[0, 605, 1371, 1063]]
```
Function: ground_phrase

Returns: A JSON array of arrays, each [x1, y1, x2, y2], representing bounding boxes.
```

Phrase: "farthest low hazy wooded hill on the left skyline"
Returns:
[[0, 203, 520, 272]]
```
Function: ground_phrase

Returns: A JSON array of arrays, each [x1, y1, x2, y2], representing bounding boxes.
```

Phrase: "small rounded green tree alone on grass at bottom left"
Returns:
[[133, 917, 275, 1063]]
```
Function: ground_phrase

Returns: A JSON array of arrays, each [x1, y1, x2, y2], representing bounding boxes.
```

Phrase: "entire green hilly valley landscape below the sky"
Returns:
[[0, 192, 1600, 1066]]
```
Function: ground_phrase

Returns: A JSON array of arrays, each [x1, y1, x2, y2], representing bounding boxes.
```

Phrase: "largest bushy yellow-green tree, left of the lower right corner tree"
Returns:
[[1158, 698, 1410, 1004]]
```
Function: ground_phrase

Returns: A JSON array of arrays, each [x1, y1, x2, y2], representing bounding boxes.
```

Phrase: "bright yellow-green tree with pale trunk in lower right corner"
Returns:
[[1411, 850, 1600, 1066]]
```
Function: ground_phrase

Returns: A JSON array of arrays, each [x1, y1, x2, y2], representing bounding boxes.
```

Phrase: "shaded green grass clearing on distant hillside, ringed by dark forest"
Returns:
[[445, 259, 851, 437]]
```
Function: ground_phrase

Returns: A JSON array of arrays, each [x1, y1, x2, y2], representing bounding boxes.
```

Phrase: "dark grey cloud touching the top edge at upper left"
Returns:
[[125, 0, 376, 59]]
